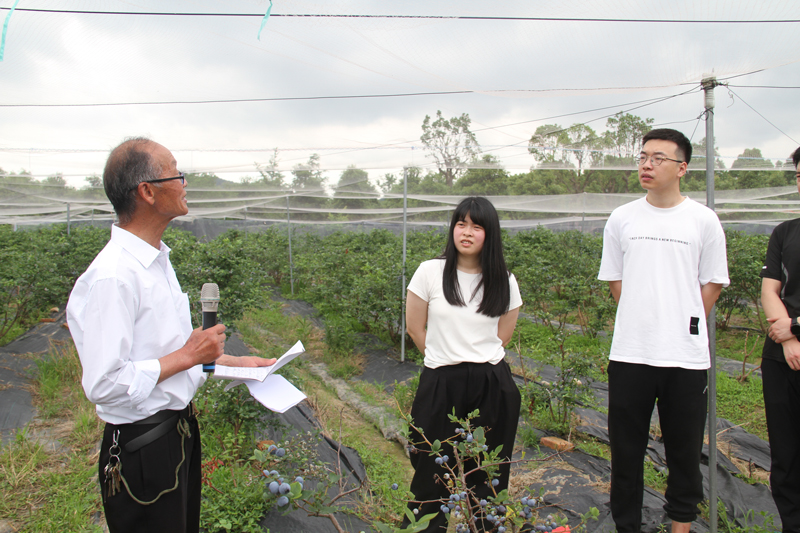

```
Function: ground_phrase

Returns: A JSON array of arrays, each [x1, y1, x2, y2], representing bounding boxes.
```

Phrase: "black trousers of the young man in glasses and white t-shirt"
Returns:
[[608, 361, 708, 533]]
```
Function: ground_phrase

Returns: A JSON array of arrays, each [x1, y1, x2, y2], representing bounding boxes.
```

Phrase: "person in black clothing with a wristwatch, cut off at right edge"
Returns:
[[761, 143, 800, 532]]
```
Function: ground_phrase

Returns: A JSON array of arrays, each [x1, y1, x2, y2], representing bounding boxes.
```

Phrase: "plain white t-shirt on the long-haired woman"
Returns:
[[408, 259, 522, 368]]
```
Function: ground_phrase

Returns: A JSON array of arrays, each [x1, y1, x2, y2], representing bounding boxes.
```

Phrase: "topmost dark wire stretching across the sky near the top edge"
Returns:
[[6, 7, 800, 24]]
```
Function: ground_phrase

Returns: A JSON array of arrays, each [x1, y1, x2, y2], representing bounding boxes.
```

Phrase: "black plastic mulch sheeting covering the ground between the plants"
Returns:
[[0, 300, 779, 533]]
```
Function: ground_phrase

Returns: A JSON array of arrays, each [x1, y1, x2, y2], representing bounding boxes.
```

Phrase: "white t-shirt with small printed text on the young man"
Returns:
[[597, 198, 730, 370]]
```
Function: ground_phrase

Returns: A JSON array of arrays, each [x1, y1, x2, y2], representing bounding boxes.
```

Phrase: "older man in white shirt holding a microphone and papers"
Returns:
[[67, 138, 275, 533]]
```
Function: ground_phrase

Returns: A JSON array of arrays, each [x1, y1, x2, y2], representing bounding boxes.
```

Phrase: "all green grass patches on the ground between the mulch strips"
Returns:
[[0, 302, 766, 531]]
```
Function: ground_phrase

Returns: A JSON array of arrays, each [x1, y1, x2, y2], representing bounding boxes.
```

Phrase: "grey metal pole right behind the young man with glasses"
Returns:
[[702, 76, 718, 533]]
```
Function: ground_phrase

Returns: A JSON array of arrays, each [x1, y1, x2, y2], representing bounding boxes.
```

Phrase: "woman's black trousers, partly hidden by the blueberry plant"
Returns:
[[403, 360, 521, 533]]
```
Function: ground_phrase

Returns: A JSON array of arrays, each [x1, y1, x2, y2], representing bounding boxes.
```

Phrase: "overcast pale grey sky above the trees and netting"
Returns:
[[0, 0, 800, 186]]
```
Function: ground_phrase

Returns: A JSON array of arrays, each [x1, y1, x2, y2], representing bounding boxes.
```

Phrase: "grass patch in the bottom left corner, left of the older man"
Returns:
[[0, 344, 101, 531]]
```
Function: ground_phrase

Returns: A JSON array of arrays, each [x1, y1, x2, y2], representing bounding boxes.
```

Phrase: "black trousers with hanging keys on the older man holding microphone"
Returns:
[[98, 410, 202, 533]]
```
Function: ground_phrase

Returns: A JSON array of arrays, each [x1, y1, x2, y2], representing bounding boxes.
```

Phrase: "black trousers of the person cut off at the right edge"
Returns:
[[761, 359, 800, 532]]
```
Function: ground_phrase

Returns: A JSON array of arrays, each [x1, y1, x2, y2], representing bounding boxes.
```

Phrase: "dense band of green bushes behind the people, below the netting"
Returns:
[[0, 225, 769, 344]]
